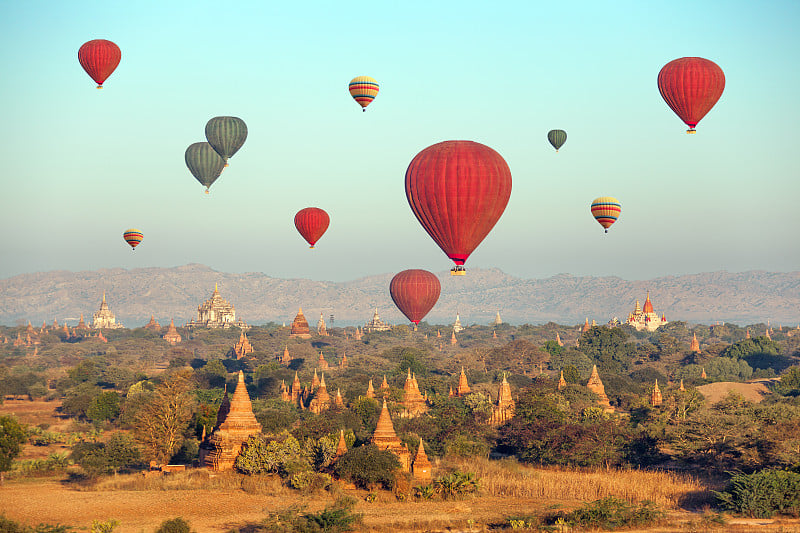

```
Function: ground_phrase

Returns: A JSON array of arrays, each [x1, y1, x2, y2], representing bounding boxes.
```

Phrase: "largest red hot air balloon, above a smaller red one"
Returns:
[[406, 141, 511, 276]]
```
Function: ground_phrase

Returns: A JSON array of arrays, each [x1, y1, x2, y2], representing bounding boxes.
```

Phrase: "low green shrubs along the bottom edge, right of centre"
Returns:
[[548, 496, 666, 530]]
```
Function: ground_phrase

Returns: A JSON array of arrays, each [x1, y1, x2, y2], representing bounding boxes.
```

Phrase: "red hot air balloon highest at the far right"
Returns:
[[658, 57, 725, 133]]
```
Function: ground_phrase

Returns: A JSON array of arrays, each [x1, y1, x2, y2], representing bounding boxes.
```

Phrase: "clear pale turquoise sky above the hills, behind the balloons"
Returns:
[[0, 1, 800, 281]]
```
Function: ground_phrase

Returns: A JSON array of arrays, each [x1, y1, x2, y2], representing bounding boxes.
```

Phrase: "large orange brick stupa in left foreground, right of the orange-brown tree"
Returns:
[[200, 370, 261, 471]]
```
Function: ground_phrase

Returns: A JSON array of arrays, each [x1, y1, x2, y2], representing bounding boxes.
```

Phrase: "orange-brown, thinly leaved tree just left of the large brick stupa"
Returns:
[[133, 370, 194, 463]]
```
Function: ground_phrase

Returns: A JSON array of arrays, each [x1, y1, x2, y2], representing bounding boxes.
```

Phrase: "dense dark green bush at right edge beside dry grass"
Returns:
[[715, 470, 800, 518]]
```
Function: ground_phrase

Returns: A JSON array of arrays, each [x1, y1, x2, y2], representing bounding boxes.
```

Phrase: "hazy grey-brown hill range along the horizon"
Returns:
[[0, 264, 800, 327]]
